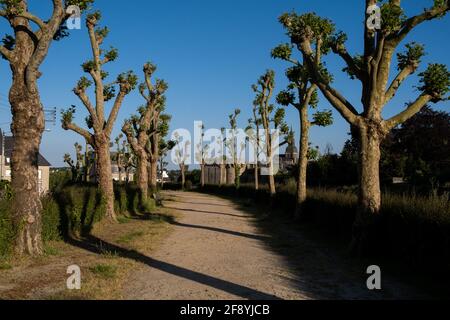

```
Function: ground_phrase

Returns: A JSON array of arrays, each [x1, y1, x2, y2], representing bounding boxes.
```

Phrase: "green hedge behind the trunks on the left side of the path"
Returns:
[[0, 184, 155, 258]]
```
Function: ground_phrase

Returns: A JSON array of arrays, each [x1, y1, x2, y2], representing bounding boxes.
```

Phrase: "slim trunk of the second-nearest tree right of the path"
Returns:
[[295, 108, 309, 219]]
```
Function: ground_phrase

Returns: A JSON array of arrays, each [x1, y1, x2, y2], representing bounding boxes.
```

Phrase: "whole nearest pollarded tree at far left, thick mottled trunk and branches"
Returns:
[[0, 0, 93, 255]]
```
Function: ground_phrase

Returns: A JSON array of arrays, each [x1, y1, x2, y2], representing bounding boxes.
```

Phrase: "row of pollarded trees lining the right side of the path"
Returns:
[[197, 0, 450, 253]]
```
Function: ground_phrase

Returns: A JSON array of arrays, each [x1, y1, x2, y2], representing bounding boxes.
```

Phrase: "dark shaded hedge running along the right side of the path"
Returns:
[[200, 186, 450, 271]]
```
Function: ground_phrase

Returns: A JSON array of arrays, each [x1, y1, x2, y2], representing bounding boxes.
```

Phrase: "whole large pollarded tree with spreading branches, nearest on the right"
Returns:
[[280, 0, 450, 252]]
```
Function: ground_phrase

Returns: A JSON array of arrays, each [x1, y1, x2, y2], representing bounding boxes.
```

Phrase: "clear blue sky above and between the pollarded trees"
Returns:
[[0, 0, 450, 166]]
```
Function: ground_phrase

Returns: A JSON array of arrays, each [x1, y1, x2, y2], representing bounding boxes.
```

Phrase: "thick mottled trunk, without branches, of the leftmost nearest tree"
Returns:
[[10, 87, 45, 255]]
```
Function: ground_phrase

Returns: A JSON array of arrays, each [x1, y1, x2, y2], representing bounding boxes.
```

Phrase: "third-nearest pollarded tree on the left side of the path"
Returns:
[[122, 63, 167, 205]]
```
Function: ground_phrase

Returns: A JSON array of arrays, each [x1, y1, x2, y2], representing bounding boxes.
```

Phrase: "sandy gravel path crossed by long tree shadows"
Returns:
[[124, 192, 428, 300]]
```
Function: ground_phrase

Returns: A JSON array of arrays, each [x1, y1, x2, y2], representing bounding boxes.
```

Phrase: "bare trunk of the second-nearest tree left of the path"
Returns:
[[95, 141, 117, 221]]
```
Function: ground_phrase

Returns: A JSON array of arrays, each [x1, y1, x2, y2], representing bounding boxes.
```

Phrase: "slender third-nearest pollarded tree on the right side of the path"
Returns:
[[252, 70, 289, 195]]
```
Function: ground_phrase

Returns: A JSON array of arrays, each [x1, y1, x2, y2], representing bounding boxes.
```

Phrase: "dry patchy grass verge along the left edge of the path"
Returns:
[[0, 195, 178, 300]]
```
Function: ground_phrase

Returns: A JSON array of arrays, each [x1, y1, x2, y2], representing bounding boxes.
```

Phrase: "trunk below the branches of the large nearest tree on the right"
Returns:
[[351, 125, 383, 255]]
